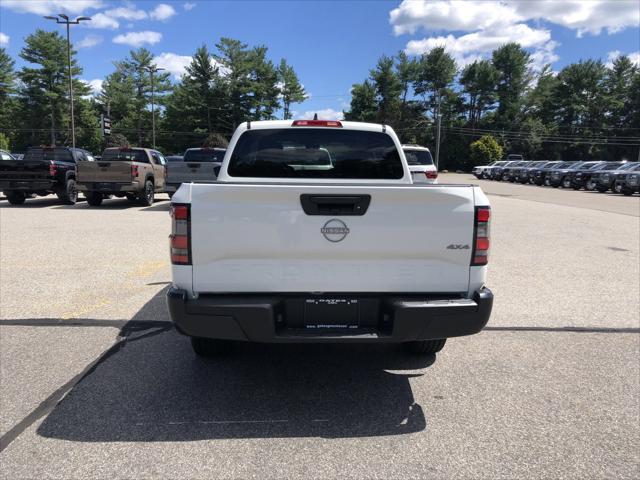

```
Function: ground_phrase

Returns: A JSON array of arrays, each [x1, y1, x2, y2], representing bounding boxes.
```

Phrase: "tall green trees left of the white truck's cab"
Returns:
[[0, 30, 307, 153]]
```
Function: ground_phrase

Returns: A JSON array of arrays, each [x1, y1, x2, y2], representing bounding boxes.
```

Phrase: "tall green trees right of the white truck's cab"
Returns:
[[345, 43, 640, 169]]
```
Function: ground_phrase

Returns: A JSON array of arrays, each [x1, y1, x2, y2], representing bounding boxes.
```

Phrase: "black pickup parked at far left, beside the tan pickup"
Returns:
[[0, 147, 93, 205]]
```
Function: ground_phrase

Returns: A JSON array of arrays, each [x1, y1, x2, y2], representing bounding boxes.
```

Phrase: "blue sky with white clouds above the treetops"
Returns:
[[0, 0, 640, 117]]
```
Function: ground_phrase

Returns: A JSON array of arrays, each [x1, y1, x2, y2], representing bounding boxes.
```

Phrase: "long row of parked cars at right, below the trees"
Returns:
[[473, 160, 640, 195]]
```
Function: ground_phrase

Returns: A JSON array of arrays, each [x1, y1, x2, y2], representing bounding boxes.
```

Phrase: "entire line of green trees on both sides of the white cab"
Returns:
[[0, 30, 640, 169]]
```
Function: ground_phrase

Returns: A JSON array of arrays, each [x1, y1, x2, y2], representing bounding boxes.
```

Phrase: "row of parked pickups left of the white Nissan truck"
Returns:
[[0, 147, 225, 206]]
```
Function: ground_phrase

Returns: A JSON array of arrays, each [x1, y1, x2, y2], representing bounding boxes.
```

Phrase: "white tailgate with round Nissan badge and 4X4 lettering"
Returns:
[[189, 183, 474, 293]]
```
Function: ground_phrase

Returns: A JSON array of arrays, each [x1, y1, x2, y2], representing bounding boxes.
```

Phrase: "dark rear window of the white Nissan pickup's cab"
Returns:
[[227, 128, 404, 179]]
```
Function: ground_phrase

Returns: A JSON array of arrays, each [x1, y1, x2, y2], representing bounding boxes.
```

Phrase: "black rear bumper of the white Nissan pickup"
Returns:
[[167, 287, 493, 343]]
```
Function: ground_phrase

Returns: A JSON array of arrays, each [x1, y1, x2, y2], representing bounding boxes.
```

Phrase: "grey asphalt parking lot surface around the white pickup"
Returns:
[[0, 174, 640, 478]]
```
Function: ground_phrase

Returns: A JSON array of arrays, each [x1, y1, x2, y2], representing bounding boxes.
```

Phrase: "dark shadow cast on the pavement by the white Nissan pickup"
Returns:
[[37, 289, 435, 442]]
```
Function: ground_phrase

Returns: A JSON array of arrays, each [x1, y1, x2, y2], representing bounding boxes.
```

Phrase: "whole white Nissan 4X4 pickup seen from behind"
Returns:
[[167, 120, 493, 356]]
